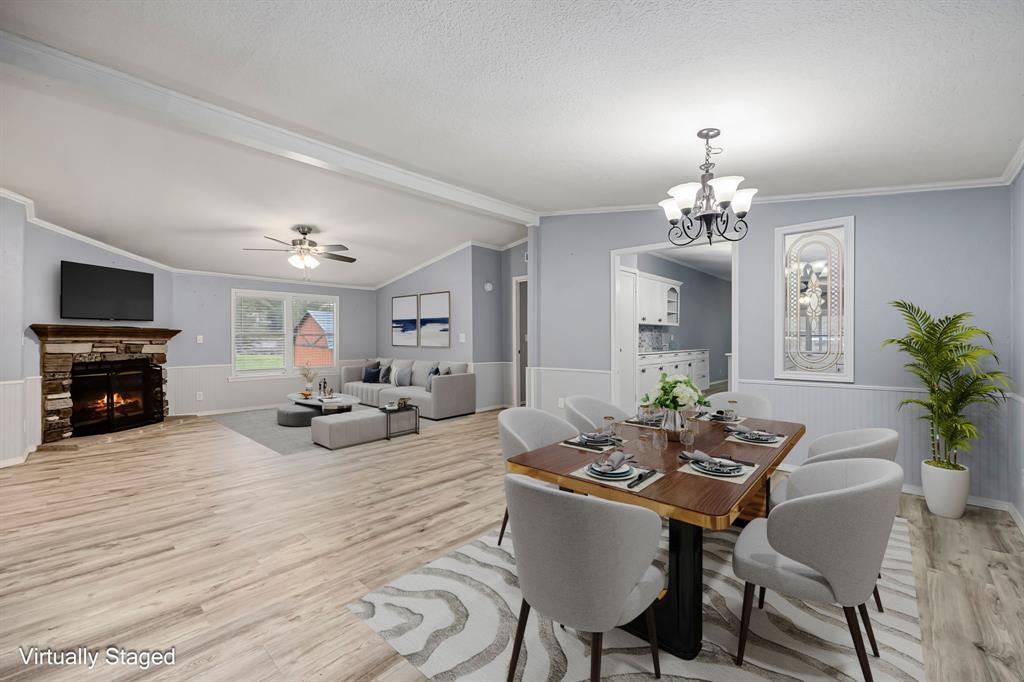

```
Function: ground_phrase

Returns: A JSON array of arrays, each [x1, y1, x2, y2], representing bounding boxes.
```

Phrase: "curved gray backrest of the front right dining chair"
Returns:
[[768, 459, 903, 606]]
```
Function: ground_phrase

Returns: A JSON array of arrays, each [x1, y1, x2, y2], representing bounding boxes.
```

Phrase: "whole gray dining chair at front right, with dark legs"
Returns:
[[732, 459, 903, 682]]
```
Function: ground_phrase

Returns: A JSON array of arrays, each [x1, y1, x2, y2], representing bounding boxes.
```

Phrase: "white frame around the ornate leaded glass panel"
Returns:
[[774, 216, 855, 383]]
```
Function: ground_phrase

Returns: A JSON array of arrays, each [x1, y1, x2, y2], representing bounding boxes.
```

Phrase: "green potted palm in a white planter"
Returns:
[[883, 301, 1009, 518]]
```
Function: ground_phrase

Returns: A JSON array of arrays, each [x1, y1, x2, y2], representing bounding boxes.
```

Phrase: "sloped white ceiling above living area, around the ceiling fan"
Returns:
[[0, 67, 525, 286]]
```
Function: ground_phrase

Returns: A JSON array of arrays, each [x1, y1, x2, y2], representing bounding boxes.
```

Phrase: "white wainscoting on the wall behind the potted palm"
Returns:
[[737, 379, 1010, 499]]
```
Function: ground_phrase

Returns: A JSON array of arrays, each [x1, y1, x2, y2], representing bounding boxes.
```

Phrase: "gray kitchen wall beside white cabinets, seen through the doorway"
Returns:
[[636, 253, 732, 382]]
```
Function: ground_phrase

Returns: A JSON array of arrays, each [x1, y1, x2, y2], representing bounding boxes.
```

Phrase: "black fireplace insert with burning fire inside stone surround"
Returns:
[[71, 359, 164, 436]]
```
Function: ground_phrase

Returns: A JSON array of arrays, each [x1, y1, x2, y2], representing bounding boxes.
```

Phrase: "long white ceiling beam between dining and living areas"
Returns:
[[0, 31, 540, 225]]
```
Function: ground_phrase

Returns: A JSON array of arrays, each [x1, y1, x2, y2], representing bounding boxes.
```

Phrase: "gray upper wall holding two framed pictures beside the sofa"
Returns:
[[377, 246, 473, 363]]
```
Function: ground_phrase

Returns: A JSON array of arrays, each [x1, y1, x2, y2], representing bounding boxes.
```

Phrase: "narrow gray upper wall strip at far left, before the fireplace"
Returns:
[[0, 198, 26, 381]]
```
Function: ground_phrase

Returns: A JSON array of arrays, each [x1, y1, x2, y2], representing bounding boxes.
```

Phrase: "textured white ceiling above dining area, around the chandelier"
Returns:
[[0, 0, 1024, 211]]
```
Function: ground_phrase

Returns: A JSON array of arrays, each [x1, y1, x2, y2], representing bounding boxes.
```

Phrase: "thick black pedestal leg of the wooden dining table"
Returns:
[[624, 519, 703, 659]]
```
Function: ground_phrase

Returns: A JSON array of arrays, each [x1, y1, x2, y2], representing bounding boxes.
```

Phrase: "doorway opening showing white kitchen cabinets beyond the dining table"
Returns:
[[611, 242, 737, 414]]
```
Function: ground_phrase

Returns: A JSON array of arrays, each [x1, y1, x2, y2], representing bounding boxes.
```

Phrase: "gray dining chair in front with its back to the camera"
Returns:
[[505, 474, 666, 682]]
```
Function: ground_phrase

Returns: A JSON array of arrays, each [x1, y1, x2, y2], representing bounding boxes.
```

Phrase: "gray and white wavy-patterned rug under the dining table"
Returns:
[[349, 518, 925, 682]]
